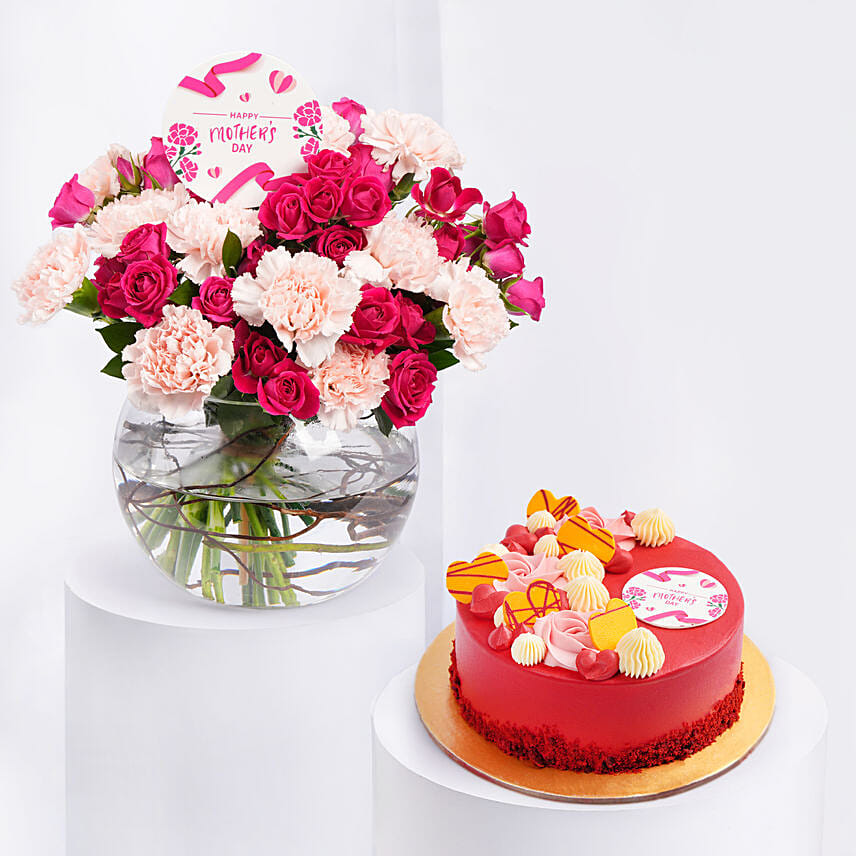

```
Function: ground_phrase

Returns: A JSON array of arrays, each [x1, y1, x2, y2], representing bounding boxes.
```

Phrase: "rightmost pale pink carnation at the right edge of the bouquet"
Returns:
[[436, 259, 511, 371]]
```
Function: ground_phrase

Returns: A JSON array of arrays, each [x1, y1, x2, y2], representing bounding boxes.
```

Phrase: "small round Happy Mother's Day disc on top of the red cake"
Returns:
[[621, 568, 728, 629]]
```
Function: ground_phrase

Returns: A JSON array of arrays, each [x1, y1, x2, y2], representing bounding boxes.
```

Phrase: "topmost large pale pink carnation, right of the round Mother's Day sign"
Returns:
[[360, 109, 464, 181]]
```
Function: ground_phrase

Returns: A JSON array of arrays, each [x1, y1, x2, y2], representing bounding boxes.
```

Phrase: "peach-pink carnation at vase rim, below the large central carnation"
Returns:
[[312, 342, 389, 431]]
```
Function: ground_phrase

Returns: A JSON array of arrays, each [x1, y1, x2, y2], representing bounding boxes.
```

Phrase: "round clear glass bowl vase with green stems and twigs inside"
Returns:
[[113, 399, 419, 607]]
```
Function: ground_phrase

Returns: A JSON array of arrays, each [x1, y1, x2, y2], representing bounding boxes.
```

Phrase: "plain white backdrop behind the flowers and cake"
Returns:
[[0, 0, 856, 856]]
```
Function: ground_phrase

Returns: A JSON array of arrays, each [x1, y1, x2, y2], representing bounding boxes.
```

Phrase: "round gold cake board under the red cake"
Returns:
[[415, 623, 776, 803]]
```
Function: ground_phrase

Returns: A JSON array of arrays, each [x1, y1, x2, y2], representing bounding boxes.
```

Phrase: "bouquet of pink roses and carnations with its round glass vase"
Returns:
[[14, 93, 544, 606]]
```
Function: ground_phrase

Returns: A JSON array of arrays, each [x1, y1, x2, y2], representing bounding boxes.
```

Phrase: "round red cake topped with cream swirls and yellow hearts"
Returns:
[[448, 491, 743, 773]]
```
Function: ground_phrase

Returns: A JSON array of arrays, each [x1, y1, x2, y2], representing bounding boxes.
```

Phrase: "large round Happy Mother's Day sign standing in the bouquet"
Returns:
[[163, 52, 322, 208]]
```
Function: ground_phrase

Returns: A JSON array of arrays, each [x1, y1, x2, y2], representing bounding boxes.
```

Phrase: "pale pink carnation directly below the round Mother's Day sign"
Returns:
[[166, 200, 261, 285]]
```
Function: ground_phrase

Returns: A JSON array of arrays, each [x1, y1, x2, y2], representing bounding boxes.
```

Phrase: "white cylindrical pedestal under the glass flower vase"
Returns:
[[66, 543, 425, 856]]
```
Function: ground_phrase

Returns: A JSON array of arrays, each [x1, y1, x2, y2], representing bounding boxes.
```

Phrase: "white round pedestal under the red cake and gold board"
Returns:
[[372, 658, 827, 856]]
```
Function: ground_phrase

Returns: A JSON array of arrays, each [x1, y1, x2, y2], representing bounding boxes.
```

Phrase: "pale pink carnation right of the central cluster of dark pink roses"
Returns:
[[345, 212, 444, 300]]
